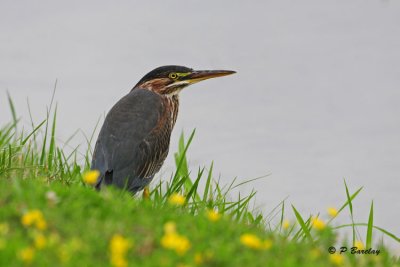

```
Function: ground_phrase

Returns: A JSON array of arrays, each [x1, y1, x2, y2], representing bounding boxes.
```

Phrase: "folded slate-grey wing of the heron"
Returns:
[[92, 89, 169, 191]]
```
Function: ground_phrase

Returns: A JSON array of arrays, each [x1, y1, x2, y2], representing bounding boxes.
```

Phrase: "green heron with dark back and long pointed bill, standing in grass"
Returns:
[[91, 66, 235, 194]]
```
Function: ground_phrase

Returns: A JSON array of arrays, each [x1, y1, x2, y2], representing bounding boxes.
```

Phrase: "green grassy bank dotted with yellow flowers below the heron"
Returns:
[[0, 97, 400, 267]]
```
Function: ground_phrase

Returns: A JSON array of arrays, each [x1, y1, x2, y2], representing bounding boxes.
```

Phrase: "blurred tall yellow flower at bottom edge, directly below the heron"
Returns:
[[110, 234, 132, 267]]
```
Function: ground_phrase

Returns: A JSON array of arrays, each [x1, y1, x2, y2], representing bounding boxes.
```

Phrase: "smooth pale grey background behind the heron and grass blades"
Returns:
[[0, 0, 400, 254]]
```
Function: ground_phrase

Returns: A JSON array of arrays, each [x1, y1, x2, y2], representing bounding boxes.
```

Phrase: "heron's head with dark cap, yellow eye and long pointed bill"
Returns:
[[133, 65, 235, 95]]
